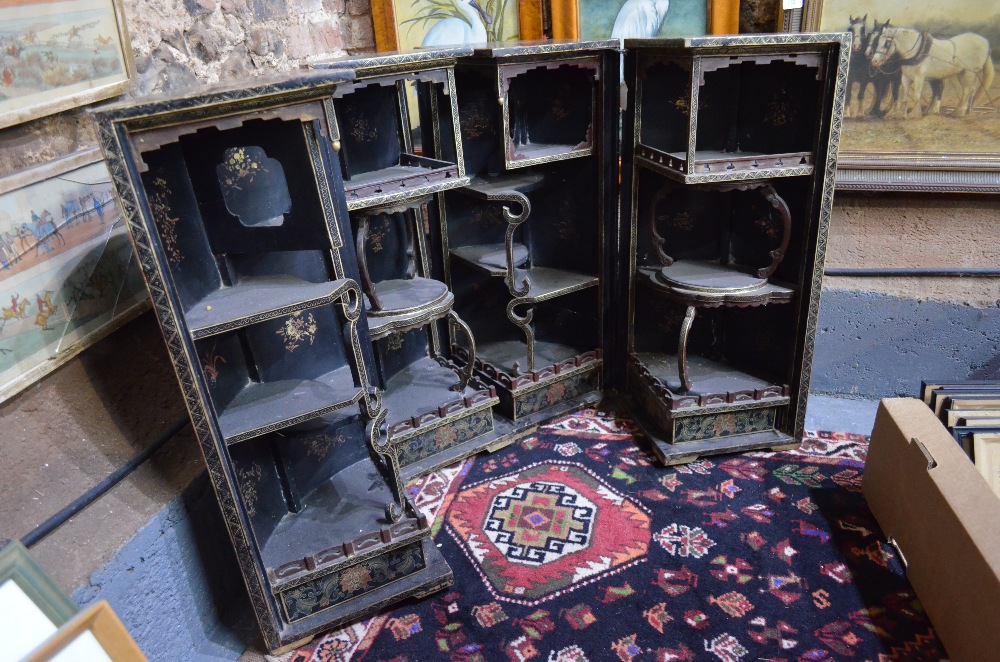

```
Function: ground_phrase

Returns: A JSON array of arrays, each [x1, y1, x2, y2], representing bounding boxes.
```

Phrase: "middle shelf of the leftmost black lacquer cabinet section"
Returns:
[[218, 366, 364, 444]]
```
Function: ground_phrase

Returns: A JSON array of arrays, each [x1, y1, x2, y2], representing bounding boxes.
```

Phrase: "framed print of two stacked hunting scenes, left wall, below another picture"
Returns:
[[0, 148, 148, 402]]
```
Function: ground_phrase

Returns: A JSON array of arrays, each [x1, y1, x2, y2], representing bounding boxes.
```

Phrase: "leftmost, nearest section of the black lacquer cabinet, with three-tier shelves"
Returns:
[[98, 65, 457, 650]]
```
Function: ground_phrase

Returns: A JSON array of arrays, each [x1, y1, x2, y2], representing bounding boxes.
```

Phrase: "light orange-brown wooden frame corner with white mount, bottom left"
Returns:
[[25, 600, 146, 662]]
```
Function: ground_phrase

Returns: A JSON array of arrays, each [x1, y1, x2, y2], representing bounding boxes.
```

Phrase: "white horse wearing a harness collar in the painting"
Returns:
[[872, 28, 994, 117]]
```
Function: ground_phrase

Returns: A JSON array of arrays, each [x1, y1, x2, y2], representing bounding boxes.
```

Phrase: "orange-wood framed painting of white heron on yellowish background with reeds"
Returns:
[[372, 0, 528, 53]]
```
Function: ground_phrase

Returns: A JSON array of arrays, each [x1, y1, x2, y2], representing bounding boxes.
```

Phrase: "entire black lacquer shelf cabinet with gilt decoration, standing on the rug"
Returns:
[[95, 34, 850, 650]]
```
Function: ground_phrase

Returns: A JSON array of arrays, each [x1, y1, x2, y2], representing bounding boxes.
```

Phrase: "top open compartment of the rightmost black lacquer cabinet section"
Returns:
[[630, 40, 829, 184]]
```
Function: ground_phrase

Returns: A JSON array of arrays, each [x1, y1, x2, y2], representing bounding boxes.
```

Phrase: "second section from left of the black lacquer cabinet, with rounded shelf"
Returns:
[[334, 57, 508, 479]]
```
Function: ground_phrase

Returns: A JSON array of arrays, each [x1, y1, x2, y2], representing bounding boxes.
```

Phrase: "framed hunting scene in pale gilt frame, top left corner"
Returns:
[[0, 0, 135, 128]]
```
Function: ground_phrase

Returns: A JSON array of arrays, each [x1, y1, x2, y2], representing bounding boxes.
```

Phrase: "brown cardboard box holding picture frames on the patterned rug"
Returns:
[[862, 398, 1000, 662]]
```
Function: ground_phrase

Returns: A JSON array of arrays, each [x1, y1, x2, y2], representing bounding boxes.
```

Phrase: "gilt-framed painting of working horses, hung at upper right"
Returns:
[[802, 0, 1000, 193]]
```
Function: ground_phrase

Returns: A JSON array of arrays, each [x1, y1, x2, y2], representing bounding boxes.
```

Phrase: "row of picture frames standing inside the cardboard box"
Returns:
[[920, 380, 1000, 497]]
